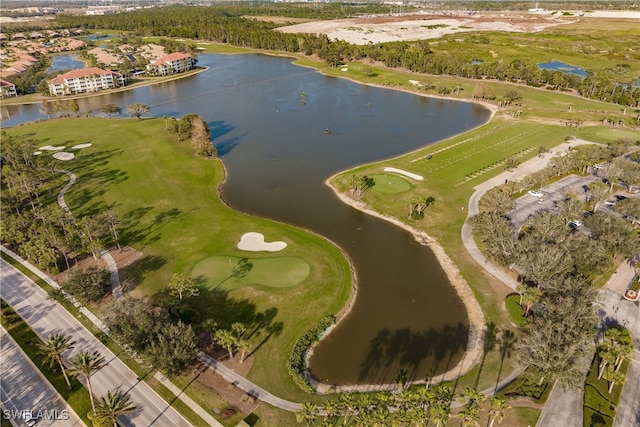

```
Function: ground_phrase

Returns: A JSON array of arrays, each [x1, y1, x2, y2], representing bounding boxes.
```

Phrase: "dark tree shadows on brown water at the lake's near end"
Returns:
[[358, 323, 469, 384]]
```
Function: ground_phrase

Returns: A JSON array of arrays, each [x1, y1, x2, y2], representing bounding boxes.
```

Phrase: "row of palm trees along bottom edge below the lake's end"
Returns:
[[296, 386, 510, 427]]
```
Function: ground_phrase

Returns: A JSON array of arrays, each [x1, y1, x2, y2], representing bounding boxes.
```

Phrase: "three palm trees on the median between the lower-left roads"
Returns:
[[38, 332, 136, 427]]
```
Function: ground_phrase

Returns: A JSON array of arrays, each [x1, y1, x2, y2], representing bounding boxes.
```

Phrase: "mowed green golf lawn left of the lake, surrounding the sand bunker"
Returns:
[[7, 118, 351, 400]]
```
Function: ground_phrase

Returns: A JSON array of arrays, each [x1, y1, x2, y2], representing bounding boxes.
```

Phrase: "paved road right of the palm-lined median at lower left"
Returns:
[[0, 260, 190, 427]]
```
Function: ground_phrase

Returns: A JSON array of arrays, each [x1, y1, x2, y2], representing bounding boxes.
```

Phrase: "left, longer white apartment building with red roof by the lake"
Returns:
[[47, 68, 126, 96]]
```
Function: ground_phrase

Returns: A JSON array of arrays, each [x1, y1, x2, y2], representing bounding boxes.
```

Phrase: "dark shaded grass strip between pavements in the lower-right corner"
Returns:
[[583, 354, 629, 426]]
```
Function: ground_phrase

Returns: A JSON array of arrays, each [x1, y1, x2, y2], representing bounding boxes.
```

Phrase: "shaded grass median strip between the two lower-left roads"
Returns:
[[0, 300, 92, 425]]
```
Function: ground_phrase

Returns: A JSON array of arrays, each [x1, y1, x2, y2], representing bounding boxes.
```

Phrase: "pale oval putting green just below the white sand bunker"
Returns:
[[191, 256, 310, 290]]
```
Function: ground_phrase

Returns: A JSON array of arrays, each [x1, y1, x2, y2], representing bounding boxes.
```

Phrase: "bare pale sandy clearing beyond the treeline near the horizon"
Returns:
[[278, 11, 640, 45]]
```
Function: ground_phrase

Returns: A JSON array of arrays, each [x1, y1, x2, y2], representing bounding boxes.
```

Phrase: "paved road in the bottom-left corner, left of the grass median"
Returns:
[[0, 326, 84, 427]]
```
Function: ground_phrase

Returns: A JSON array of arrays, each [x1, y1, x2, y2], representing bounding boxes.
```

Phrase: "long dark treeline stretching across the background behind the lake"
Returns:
[[57, 6, 640, 108]]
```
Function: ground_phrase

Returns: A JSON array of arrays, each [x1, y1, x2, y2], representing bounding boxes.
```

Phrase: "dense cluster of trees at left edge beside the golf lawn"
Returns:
[[0, 133, 121, 271]]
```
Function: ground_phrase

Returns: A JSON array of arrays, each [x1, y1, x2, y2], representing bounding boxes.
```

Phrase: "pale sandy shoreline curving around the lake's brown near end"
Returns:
[[306, 172, 486, 394]]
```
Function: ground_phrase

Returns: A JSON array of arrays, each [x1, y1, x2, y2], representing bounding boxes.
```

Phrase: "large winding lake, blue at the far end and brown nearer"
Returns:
[[2, 55, 489, 385]]
